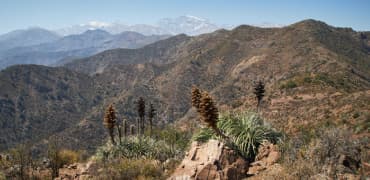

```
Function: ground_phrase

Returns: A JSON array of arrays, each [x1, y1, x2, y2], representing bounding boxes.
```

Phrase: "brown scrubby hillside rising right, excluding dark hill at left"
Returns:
[[67, 20, 370, 141]]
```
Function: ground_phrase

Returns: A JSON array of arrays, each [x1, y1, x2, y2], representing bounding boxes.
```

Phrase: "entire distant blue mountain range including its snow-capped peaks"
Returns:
[[0, 16, 236, 70]]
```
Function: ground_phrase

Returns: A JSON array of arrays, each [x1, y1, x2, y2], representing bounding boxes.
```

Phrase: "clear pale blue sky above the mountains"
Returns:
[[0, 0, 370, 33]]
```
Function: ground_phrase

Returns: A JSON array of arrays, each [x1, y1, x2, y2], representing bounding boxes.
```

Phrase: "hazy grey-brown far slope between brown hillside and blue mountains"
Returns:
[[65, 34, 190, 74]]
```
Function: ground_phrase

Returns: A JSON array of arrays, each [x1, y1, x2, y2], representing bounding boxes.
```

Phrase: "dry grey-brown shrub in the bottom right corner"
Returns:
[[281, 128, 362, 179]]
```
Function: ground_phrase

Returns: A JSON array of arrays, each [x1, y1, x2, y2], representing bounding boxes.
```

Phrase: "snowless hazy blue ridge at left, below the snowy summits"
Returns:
[[0, 30, 169, 69]]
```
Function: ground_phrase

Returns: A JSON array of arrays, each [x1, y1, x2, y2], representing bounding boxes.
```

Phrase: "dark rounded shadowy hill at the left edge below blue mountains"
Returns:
[[0, 65, 101, 149]]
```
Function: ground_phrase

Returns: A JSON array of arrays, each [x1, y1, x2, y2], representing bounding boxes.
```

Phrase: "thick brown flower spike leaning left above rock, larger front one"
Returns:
[[199, 91, 226, 138]]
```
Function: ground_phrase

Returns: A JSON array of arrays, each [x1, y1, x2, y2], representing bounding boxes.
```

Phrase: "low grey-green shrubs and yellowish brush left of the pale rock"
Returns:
[[93, 126, 191, 179]]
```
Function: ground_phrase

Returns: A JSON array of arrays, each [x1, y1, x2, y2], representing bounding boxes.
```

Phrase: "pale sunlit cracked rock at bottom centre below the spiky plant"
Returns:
[[169, 140, 248, 180]]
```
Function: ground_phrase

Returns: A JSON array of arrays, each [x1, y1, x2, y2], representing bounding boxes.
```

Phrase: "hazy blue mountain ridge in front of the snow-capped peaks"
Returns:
[[0, 29, 169, 69]]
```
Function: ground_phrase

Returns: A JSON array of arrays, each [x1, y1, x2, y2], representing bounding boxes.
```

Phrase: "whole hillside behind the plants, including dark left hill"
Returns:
[[0, 20, 370, 153]]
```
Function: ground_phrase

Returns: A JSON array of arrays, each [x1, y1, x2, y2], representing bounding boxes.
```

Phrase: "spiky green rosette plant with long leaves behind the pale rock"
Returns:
[[194, 112, 281, 158]]
